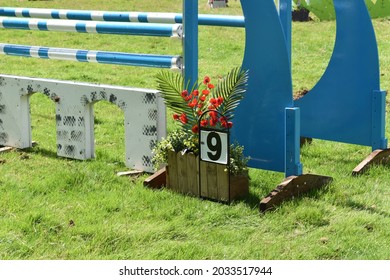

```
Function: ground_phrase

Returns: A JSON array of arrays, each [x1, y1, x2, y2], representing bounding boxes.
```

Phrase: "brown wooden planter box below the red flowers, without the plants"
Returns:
[[166, 151, 249, 202]]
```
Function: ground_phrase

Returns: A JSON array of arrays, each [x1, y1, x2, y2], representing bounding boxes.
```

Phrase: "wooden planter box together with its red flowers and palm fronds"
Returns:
[[153, 67, 249, 202]]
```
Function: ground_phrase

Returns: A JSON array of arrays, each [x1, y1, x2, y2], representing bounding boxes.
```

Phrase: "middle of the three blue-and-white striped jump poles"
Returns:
[[0, 17, 183, 38]]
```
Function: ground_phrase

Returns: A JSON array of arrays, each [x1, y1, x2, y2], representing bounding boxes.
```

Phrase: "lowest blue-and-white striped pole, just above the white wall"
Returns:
[[0, 43, 183, 70]]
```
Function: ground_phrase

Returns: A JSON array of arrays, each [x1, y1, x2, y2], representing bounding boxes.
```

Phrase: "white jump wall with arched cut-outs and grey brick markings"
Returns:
[[0, 75, 166, 172]]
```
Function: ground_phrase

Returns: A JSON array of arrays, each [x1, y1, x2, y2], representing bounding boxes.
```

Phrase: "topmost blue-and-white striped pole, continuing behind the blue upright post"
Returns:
[[0, 7, 245, 27]]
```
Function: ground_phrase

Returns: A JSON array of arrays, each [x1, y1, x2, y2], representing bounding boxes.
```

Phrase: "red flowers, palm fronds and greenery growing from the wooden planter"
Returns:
[[153, 67, 248, 174]]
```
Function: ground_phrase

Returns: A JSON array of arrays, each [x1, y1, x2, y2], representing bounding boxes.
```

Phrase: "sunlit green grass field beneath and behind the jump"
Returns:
[[0, 0, 390, 260]]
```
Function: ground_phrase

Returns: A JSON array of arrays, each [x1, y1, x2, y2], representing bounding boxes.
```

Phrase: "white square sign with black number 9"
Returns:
[[200, 130, 229, 164]]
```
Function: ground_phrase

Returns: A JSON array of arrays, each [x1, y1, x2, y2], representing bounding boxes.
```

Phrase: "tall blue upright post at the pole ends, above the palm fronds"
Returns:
[[183, 0, 198, 89]]
